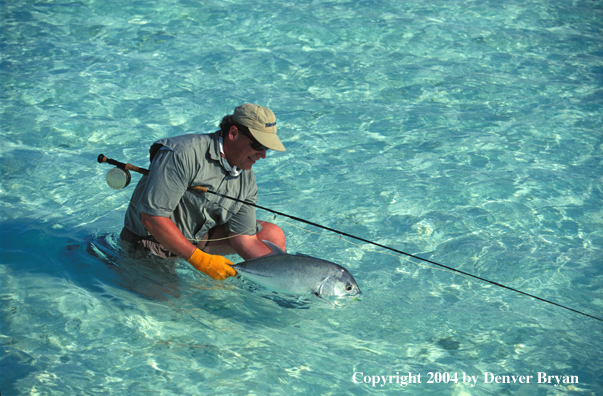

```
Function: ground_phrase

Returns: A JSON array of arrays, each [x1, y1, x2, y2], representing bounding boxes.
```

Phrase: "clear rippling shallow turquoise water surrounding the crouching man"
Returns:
[[0, 0, 603, 395]]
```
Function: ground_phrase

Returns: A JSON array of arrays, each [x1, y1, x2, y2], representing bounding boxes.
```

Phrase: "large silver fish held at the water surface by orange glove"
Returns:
[[233, 241, 361, 297]]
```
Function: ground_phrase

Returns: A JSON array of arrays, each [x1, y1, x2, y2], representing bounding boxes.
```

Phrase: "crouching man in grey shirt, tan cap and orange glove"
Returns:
[[120, 103, 286, 279]]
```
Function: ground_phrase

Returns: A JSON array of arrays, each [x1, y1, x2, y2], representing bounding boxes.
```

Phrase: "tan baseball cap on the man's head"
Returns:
[[233, 103, 285, 151]]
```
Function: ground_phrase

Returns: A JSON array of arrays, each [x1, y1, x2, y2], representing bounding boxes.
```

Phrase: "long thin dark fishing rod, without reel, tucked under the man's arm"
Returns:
[[97, 154, 603, 322]]
